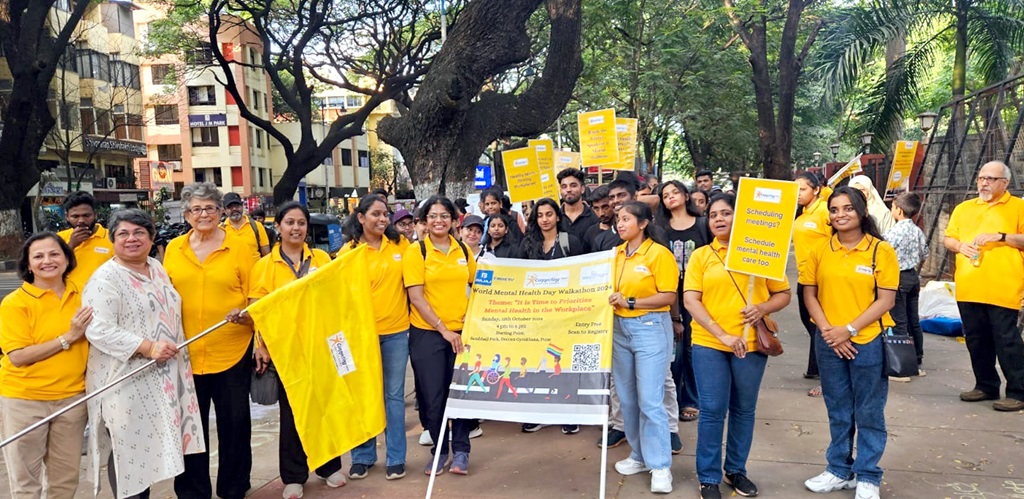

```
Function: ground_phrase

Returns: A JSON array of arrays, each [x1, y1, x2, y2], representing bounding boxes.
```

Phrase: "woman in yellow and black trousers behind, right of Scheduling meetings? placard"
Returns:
[[793, 171, 831, 397]]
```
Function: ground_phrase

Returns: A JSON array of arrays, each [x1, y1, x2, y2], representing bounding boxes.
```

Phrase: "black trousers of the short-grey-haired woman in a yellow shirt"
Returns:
[[174, 343, 253, 499]]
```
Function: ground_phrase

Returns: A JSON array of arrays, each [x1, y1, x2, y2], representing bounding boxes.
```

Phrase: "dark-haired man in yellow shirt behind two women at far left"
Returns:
[[57, 191, 114, 289]]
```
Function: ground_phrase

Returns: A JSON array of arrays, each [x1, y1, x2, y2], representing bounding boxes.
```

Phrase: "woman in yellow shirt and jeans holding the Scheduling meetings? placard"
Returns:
[[683, 195, 790, 499]]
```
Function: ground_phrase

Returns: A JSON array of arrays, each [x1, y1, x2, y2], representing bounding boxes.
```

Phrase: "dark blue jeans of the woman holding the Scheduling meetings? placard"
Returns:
[[693, 345, 768, 484]]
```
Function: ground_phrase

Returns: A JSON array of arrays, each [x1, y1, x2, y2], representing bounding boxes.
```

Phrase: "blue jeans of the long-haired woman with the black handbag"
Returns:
[[814, 335, 889, 485]]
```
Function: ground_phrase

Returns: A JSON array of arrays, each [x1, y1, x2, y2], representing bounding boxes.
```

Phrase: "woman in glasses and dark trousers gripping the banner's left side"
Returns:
[[402, 196, 476, 474]]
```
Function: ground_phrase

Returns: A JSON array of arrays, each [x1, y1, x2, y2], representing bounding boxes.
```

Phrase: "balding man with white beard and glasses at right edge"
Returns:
[[944, 161, 1024, 412]]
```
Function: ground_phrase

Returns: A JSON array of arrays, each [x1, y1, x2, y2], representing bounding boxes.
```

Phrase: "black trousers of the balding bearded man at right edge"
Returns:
[[956, 301, 1024, 401]]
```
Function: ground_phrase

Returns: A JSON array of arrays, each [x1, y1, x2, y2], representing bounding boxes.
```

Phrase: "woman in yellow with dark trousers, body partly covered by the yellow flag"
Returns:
[[249, 202, 345, 499]]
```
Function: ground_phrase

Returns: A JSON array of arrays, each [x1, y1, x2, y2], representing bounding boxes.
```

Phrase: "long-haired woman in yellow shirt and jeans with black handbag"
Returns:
[[800, 186, 899, 499]]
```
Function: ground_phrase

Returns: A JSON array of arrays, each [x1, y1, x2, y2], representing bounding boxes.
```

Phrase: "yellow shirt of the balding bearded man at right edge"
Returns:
[[946, 193, 1024, 310]]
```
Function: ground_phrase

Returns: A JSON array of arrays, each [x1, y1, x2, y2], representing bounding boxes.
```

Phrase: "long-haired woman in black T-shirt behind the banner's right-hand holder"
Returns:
[[656, 180, 712, 421]]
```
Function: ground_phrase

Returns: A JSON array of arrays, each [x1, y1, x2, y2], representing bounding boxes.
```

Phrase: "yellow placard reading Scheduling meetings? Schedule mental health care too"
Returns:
[[725, 177, 799, 281]]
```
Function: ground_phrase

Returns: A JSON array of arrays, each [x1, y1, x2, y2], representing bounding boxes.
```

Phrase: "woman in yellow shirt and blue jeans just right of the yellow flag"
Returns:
[[339, 195, 409, 480]]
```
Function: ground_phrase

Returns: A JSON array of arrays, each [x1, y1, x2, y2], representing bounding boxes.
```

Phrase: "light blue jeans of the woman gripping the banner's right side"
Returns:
[[611, 311, 673, 469]]
